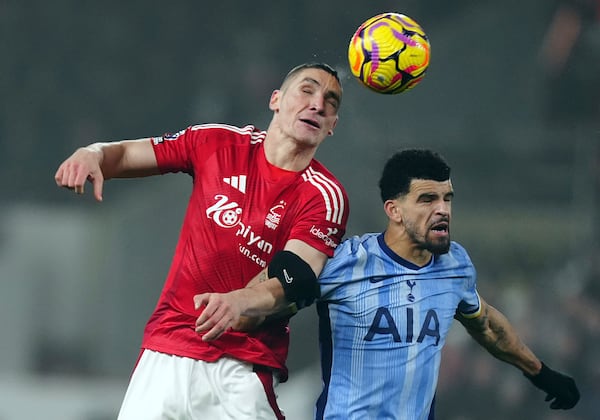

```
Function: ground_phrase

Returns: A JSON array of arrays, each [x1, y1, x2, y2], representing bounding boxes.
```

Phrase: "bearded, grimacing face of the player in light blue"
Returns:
[[398, 179, 454, 254]]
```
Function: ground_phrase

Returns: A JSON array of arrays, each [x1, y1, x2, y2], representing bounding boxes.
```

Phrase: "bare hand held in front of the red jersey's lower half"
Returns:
[[194, 291, 250, 341]]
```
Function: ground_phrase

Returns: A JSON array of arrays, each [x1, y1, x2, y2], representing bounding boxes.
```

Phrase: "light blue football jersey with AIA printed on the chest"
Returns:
[[316, 233, 480, 420]]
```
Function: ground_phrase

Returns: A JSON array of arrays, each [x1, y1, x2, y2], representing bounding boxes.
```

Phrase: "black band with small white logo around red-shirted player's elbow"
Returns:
[[268, 251, 319, 309]]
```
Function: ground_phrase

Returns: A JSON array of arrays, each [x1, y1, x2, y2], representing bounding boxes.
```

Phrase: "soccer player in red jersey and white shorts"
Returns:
[[55, 63, 348, 420]]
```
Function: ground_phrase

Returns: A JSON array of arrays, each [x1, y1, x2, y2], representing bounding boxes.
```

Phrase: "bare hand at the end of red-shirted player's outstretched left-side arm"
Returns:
[[54, 147, 104, 201]]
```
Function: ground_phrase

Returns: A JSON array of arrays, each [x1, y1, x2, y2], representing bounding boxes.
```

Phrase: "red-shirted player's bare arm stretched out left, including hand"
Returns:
[[54, 139, 158, 201]]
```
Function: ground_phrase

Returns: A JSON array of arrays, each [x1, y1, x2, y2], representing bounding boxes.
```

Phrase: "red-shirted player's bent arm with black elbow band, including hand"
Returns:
[[194, 239, 327, 341]]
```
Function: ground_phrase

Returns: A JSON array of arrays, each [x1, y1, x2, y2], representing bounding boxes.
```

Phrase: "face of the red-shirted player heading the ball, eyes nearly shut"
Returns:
[[269, 68, 342, 146]]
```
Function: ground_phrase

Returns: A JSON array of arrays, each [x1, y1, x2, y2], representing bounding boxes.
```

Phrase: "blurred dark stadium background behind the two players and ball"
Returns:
[[0, 0, 600, 420]]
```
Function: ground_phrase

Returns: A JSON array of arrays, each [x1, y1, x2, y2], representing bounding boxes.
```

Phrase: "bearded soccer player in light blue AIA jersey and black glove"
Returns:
[[316, 150, 579, 420]]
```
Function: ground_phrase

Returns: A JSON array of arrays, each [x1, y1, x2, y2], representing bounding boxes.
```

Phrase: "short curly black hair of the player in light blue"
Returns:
[[379, 149, 450, 202]]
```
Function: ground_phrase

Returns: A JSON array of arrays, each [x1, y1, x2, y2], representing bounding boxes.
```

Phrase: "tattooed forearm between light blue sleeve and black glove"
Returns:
[[456, 299, 542, 375]]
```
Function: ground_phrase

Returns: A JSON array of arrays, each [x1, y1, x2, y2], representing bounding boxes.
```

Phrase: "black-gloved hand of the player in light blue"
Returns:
[[525, 362, 579, 410]]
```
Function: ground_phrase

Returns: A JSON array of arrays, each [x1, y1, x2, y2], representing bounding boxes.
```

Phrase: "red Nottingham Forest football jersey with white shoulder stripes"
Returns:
[[142, 124, 348, 380]]
